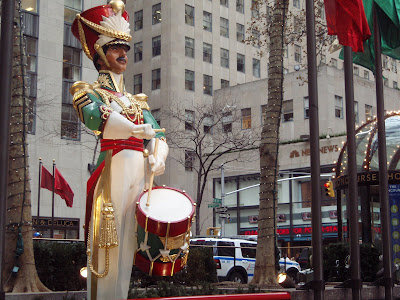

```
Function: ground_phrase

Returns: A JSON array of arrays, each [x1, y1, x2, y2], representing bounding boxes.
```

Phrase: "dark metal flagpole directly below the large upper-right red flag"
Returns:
[[344, 46, 362, 300]]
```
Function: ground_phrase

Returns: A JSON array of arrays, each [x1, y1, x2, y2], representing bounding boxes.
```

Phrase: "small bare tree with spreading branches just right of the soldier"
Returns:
[[165, 101, 260, 234]]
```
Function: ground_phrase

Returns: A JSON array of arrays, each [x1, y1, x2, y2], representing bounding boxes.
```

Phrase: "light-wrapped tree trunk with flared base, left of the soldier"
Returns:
[[3, 2, 49, 293]]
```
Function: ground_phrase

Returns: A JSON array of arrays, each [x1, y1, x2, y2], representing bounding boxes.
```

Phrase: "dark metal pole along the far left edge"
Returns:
[[0, 0, 15, 300]]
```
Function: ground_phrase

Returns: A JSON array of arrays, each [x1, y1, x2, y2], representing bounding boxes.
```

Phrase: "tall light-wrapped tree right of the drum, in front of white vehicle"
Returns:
[[245, 0, 329, 286]]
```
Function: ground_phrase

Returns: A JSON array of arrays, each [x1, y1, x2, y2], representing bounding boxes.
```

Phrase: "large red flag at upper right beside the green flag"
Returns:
[[324, 0, 371, 52]]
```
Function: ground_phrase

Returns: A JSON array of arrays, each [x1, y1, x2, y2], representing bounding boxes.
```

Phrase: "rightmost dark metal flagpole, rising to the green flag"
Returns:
[[373, 4, 393, 300]]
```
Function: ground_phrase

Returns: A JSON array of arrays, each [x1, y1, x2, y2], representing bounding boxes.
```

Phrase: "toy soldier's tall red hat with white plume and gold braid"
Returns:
[[71, 0, 132, 64]]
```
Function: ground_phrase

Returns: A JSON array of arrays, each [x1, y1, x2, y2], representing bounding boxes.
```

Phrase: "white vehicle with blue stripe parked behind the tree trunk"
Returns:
[[190, 238, 300, 283]]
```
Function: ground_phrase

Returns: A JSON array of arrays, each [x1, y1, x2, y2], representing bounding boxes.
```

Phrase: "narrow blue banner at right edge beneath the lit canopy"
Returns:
[[389, 184, 400, 263]]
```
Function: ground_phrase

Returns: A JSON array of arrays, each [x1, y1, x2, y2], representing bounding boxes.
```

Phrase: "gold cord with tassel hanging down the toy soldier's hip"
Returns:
[[87, 150, 118, 278]]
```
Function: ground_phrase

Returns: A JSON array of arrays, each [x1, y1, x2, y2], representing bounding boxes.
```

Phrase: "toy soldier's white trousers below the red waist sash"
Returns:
[[87, 150, 145, 300]]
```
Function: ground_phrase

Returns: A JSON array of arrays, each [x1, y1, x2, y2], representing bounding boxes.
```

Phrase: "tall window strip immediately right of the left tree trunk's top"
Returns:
[[21, 1, 39, 134]]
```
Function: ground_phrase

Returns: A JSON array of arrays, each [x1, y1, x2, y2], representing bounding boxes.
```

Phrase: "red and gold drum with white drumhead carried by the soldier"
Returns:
[[135, 186, 195, 276]]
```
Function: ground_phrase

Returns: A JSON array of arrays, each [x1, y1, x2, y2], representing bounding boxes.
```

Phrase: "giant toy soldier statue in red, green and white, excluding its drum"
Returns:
[[70, 0, 168, 300]]
